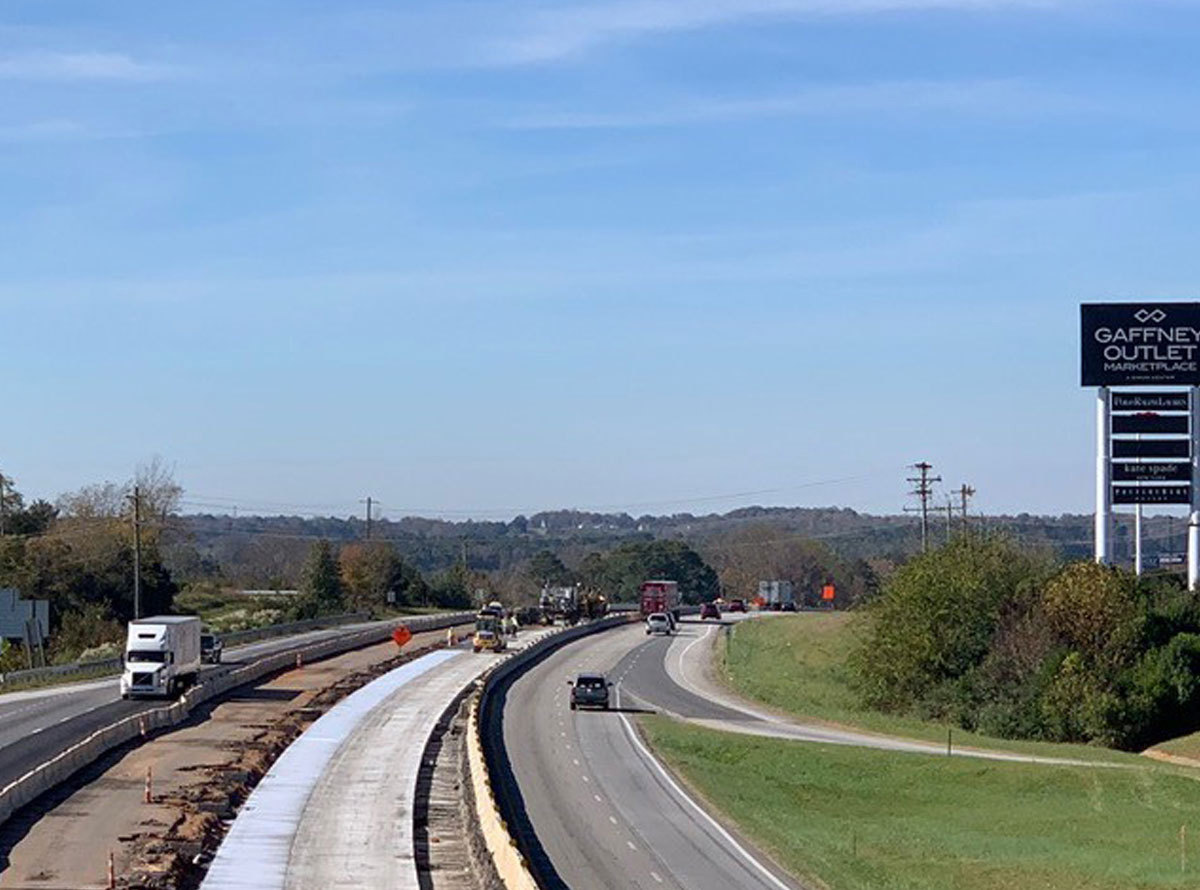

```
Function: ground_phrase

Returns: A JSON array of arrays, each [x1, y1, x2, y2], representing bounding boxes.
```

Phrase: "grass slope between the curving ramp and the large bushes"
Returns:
[[716, 612, 1140, 763]]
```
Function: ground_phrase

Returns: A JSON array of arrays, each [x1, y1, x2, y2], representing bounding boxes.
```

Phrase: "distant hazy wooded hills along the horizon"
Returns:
[[162, 507, 1171, 587]]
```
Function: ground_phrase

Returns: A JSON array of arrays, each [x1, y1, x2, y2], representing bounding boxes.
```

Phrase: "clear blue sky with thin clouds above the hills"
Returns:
[[0, 0, 1200, 517]]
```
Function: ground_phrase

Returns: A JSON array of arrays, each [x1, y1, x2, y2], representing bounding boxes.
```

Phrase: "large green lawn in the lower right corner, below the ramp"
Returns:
[[642, 717, 1200, 890]]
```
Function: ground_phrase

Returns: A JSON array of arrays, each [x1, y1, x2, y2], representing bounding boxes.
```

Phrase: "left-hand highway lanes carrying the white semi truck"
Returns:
[[0, 623, 417, 788]]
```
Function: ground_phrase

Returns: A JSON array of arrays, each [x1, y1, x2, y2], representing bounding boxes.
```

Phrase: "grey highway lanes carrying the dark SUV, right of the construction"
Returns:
[[504, 624, 799, 890]]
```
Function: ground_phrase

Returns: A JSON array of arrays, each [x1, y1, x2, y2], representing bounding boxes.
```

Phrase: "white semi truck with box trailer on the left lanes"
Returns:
[[121, 615, 200, 698]]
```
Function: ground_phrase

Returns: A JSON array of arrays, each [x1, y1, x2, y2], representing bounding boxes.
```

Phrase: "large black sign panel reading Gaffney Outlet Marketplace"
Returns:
[[1079, 302, 1200, 386]]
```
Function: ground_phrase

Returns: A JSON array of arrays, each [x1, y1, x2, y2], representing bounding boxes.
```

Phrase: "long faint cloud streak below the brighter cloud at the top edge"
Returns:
[[506, 80, 1094, 130]]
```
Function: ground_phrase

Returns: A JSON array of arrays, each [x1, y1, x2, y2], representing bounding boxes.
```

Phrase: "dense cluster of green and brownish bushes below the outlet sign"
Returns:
[[852, 534, 1200, 750]]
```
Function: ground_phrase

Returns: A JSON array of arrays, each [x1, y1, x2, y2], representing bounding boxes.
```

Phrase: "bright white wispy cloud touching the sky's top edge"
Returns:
[[492, 0, 1072, 64]]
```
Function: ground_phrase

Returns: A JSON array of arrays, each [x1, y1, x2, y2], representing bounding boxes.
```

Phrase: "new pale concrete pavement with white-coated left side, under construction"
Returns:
[[202, 630, 544, 890]]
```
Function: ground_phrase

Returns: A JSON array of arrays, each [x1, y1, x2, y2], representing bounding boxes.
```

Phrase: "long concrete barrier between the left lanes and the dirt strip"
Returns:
[[0, 612, 474, 825]]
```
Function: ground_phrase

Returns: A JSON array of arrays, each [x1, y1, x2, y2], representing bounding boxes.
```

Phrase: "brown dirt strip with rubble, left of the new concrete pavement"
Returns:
[[0, 629, 462, 890]]
